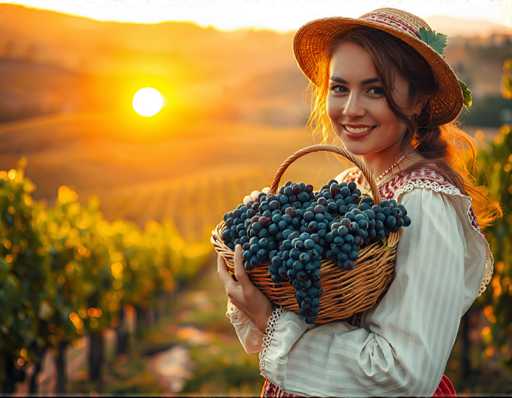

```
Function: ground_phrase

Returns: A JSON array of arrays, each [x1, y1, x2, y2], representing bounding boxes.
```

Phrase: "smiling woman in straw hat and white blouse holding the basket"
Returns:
[[218, 8, 500, 396]]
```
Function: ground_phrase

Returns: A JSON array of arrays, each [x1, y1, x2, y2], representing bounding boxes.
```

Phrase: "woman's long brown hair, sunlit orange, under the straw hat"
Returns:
[[308, 27, 502, 229]]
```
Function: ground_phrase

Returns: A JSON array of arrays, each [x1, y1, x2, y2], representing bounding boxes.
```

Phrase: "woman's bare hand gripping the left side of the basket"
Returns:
[[217, 245, 272, 333]]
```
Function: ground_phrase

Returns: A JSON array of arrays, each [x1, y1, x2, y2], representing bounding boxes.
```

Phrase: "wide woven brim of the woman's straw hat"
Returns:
[[293, 17, 464, 125]]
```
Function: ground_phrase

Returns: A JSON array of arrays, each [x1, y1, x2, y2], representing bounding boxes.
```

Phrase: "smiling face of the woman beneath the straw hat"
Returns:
[[327, 42, 417, 159]]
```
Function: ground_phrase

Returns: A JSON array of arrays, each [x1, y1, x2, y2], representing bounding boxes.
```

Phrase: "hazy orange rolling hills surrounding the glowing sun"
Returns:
[[0, 4, 504, 236]]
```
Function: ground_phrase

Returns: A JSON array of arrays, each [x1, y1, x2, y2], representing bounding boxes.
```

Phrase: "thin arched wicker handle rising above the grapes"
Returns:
[[270, 144, 380, 204]]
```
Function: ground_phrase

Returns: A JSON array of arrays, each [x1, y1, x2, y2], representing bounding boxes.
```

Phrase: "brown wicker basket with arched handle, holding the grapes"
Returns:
[[211, 145, 401, 325]]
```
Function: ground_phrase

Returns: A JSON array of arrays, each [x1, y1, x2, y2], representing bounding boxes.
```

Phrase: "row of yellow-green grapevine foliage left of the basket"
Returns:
[[0, 160, 211, 388]]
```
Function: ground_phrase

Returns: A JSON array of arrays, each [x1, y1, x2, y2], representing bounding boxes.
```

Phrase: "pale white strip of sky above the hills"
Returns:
[[0, 0, 512, 31]]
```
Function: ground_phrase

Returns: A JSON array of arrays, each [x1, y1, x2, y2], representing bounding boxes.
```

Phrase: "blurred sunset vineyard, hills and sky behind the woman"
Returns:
[[0, 0, 512, 395]]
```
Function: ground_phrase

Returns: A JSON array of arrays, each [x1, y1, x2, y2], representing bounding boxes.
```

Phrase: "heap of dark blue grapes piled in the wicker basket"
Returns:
[[222, 180, 411, 323]]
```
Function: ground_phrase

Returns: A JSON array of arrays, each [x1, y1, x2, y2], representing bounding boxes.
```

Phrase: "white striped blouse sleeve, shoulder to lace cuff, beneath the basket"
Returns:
[[260, 189, 465, 396]]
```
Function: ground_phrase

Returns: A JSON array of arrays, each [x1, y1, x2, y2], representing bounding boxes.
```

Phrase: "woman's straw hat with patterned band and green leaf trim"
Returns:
[[293, 8, 471, 124]]
